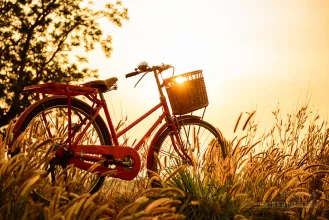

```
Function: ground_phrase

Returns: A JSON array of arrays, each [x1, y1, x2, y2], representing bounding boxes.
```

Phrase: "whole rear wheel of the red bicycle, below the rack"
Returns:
[[14, 97, 112, 201]]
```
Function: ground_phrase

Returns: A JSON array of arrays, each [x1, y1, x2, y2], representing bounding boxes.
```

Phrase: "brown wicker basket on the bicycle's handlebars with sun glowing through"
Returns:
[[164, 70, 209, 115]]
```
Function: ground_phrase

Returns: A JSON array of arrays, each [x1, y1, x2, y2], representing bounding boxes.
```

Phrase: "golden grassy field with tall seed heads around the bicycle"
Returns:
[[0, 105, 329, 219]]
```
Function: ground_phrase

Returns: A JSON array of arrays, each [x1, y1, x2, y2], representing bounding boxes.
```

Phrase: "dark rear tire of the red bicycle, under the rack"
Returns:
[[13, 97, 112, 201]]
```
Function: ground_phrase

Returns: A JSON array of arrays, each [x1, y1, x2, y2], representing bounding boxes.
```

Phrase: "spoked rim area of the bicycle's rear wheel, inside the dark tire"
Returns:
[[20, 106, 105, 200]]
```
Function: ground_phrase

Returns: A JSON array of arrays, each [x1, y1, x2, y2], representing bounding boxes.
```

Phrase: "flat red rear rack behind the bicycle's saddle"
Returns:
[[23, 83, 98, 96]]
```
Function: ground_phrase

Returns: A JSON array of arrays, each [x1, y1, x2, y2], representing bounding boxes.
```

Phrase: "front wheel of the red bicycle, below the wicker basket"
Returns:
[[148, 117, 226, 180]]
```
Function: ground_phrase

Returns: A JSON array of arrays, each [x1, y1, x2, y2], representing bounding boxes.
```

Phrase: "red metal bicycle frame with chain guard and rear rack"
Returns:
[[13, 72, 191, 180]]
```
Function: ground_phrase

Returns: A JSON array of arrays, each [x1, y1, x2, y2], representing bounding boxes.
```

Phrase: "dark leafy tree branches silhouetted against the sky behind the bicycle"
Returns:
[[0, 0, 129, 130]]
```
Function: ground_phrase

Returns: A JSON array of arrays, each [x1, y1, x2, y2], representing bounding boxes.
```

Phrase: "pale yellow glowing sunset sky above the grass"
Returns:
[[86, 0, 329, 139]]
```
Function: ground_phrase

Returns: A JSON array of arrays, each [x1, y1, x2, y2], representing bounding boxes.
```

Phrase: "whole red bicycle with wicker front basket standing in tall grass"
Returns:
[[9, 62, 225, 201]]
